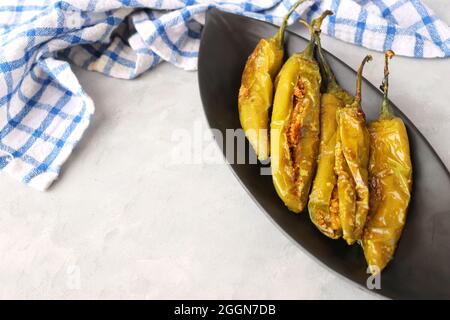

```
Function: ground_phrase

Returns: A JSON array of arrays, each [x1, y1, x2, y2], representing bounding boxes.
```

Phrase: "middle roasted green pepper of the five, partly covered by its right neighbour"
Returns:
[[308, 16, 353, 239]]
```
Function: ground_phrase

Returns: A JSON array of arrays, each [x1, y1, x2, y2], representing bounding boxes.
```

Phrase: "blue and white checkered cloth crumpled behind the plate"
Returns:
[[0, 0, 450, 190]]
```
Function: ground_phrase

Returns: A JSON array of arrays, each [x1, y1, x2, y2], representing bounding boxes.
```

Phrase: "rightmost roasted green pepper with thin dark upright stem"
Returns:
[[362, 51, 412, 273]]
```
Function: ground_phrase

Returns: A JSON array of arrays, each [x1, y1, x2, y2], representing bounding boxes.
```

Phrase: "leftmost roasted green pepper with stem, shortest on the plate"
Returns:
[[238, 0, 304, 160]]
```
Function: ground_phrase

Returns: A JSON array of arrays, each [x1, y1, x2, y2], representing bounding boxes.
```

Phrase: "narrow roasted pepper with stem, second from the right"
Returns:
[[335, 56, 372, 244]]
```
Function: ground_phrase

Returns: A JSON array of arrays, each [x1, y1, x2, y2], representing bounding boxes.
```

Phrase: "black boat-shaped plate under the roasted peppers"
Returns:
[[198, 9, 450, 298]]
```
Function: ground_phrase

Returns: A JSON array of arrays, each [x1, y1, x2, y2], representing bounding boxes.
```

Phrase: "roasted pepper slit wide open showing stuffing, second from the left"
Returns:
[[270, 13, 328, 213]]
